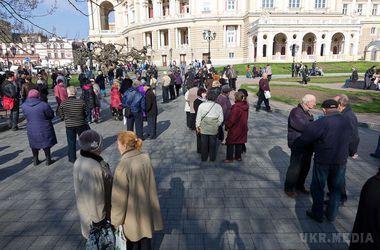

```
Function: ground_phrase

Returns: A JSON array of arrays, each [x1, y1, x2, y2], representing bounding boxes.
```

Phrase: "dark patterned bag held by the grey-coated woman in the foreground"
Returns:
[[86, 219, 115, 250]]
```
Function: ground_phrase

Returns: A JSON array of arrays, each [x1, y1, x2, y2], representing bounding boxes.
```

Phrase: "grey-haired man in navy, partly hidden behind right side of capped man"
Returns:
[[327, 94, 360, 205]]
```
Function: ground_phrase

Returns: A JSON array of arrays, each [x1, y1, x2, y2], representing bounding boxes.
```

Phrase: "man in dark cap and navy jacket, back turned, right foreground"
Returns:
[[294, 99, 354, 223]]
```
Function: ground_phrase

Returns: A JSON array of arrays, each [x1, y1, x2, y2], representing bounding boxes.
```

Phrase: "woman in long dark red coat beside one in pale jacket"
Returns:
[[223, 91, 249, 163]]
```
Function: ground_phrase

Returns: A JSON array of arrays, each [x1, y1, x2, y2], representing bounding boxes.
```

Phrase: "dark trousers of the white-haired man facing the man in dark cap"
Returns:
[[285, 150, 313, 192]]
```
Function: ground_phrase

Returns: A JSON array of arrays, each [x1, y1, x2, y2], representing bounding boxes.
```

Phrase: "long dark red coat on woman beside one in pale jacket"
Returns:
[[225, 101, 249, 144]]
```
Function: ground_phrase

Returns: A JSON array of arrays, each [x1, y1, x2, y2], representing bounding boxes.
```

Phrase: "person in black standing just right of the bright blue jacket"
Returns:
[[144, 83, 158, 139]]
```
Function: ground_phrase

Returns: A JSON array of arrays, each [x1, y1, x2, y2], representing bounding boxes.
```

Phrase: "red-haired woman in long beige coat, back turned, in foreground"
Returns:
[[111, 131, 163, 250]]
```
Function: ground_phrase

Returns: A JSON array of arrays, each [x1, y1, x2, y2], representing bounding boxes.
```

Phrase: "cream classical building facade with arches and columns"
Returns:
[[88, 0, 380, 65]]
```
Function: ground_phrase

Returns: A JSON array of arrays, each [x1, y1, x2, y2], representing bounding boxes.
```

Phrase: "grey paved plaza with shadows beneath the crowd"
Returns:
[[0, 81, 379, 250]]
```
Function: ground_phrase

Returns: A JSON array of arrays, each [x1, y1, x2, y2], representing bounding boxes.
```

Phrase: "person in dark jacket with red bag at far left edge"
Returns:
[[1, 71, 20, 131]]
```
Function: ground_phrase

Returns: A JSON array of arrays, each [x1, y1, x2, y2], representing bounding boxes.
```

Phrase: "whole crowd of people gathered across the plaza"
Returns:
[[1, 61, 380, 249]]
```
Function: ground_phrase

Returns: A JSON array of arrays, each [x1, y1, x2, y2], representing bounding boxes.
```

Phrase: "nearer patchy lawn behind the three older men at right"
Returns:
[[241, 84, 380, 113]]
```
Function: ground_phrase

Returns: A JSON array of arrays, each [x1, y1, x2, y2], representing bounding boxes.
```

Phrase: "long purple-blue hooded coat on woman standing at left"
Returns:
[[21, 98, 57, 149]]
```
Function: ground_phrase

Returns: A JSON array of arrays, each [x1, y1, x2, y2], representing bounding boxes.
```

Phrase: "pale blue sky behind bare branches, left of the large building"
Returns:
[[32, 0, 89, 39]]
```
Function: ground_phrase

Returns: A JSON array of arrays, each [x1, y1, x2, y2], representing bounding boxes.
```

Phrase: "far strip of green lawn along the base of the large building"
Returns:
[[216, 61, 380, 75]]
